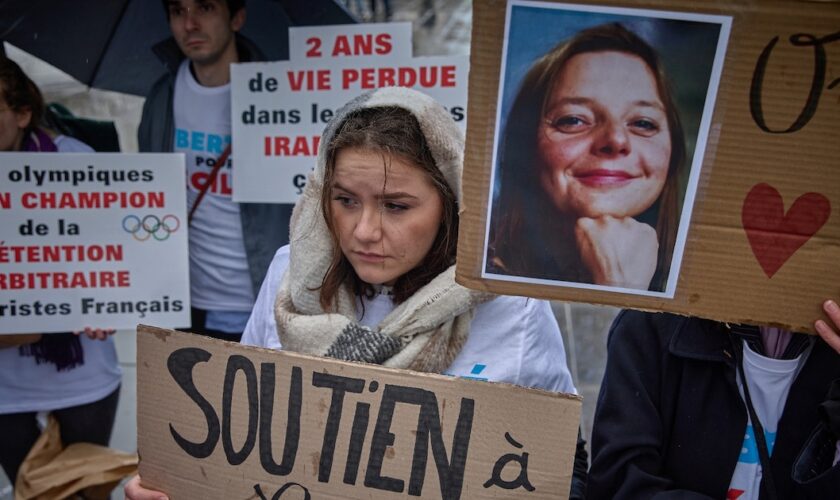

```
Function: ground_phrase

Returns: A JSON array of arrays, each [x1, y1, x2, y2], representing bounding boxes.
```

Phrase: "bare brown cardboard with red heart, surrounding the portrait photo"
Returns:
[[457, 0, 840, 332]]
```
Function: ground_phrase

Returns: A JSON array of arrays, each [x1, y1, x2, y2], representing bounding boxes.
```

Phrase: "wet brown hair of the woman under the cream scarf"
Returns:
[[320, 107, 458, 310]]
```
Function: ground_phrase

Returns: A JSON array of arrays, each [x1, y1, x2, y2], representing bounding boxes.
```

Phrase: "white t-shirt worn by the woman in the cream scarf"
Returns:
[[242, 245, 576, 394]]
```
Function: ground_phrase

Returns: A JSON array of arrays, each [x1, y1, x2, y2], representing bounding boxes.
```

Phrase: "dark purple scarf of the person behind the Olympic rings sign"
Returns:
[[18, 128, 85, 371]]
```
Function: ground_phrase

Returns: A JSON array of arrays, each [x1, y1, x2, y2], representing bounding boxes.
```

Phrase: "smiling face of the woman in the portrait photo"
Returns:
[[537, 52, 671, 217]]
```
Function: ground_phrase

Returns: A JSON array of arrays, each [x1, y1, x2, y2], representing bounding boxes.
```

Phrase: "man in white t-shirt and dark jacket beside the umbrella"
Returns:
[[138, 0, 292, 341]]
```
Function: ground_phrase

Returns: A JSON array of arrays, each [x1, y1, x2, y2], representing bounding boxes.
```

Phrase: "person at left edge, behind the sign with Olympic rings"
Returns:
[[0, 56, 122, 492]]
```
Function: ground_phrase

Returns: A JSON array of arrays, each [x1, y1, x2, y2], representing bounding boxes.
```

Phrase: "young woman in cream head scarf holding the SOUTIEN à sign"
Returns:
[[126, 87, 586, 500]]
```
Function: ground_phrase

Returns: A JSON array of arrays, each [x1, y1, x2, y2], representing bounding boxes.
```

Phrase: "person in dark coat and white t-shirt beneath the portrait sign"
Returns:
[[587, 300, 840, 500]]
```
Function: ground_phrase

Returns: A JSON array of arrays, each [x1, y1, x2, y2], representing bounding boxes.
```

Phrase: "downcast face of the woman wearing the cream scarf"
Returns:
[[330, 148, 443, 285]]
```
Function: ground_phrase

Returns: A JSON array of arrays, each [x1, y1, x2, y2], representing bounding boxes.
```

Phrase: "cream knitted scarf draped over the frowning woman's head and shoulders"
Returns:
[[275, 87, 493, 373]]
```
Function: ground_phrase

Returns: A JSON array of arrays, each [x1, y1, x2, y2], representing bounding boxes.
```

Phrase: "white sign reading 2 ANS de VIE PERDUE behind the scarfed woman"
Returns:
[[231, 23, 468, 203]]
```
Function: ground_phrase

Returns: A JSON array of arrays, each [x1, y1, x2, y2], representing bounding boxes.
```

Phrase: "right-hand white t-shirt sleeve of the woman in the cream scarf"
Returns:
[[519, 299, 577, 394]]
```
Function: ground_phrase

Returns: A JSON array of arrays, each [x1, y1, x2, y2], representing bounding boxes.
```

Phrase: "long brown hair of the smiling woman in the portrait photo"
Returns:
[[488, 23, 686, 290]]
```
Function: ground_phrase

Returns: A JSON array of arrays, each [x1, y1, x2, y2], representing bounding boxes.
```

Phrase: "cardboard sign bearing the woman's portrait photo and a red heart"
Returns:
[[457, 0, 840, 331]]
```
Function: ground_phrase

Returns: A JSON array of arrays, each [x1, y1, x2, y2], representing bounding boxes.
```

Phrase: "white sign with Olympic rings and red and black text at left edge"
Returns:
[[0, 153, 190, 333]]
